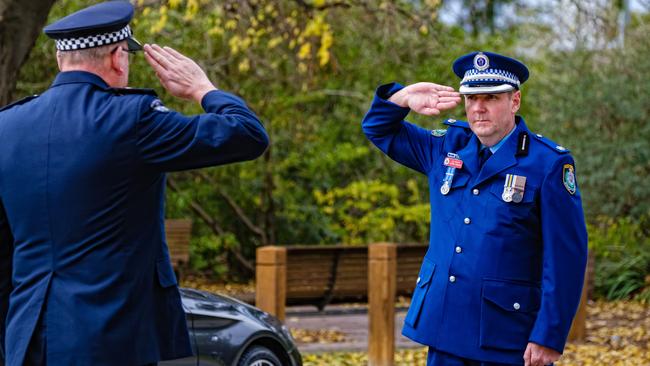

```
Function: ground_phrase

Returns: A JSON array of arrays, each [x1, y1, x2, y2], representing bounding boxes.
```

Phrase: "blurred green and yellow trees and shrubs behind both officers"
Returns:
[[14, 0, 650, 301]]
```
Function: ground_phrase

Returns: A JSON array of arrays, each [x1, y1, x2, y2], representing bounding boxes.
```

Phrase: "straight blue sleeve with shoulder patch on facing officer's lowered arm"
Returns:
[[529, 155, 587, 353]]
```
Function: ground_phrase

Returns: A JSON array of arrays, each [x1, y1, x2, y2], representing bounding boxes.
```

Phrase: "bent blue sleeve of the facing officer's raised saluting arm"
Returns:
[[361, 83, 444, 174]]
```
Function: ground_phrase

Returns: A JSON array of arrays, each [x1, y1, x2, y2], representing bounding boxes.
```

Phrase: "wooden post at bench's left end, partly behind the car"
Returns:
[[255, 246, 287, 321]]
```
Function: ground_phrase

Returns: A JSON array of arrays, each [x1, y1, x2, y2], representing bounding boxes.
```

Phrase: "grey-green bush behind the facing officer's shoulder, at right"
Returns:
[[526, 22, 650, 219]]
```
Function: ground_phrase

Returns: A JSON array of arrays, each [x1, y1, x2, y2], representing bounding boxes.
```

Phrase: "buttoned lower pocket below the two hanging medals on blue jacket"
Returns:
[[479, 279, 541, 351]]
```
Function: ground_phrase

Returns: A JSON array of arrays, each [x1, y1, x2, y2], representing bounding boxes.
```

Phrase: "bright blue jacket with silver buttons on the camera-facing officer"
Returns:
[[362, 84, 587, 364]]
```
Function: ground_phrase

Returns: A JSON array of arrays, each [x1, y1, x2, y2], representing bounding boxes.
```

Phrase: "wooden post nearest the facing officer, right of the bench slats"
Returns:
[[368, 243, 397, 366]]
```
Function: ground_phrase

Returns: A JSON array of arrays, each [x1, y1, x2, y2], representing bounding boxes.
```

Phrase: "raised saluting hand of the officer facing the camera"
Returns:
[[388, 83, 460, 116]]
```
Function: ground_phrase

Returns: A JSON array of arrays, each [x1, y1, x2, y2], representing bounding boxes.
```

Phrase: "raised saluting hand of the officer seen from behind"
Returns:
[[144, 44, 216, 103]]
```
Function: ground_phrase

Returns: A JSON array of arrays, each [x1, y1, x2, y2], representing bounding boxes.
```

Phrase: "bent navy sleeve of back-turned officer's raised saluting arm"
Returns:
[[137, 90, 269, 171]]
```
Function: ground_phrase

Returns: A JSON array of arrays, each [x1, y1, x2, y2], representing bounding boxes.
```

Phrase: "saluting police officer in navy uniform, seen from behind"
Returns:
[[0, 1, 268, 366]]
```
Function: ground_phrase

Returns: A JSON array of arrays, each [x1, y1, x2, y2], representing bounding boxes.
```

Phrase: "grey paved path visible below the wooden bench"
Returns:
[[285, 305, 422, 353]]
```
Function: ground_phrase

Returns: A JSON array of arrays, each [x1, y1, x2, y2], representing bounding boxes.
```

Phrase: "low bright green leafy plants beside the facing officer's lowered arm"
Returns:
[[588, 218, 650, 301]]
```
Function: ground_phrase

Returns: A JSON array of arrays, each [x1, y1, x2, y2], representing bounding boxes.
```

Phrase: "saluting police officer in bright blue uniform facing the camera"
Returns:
[[362, 52, 587, 366]]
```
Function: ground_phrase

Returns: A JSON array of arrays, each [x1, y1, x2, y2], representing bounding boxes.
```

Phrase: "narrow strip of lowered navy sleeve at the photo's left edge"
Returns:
[[0, 201, 14, 365]]
